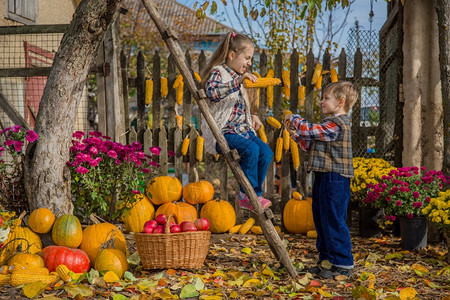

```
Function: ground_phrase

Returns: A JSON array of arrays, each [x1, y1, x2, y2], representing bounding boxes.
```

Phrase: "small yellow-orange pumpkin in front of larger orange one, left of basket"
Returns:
[[95, 249, 128, 278]]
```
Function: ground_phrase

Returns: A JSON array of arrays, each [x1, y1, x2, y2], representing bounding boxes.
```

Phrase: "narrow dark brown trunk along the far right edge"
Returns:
[[436, 0, 450, 175]]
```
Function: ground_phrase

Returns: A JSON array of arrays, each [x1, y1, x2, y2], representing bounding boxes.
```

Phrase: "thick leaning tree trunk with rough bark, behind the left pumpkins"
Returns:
[[25, 0, 122, 216]]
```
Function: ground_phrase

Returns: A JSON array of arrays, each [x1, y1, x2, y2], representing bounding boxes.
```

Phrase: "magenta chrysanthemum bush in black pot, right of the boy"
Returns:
[[365, 167, 448, 250]]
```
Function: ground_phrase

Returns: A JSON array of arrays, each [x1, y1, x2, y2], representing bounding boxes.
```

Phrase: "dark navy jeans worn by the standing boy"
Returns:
[[312, 172, 353, 267]]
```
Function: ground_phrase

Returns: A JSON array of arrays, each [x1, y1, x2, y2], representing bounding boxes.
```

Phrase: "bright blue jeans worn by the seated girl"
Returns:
[[216, 131, 273, 196]]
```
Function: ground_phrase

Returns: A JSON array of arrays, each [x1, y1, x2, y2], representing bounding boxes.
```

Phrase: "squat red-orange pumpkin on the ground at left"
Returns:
[[41, 246, 90, 273]]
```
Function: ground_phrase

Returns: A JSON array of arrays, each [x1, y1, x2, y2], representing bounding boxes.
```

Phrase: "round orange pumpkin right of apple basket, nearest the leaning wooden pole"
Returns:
[[200, 200, 236, 233]]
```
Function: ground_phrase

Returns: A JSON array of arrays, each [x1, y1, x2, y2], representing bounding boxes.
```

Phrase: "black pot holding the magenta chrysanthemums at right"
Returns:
[[399, 217, 428, 250]]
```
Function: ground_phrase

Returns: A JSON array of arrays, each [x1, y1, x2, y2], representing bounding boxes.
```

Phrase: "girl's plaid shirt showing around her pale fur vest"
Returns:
[[206, 64, 251, 139]]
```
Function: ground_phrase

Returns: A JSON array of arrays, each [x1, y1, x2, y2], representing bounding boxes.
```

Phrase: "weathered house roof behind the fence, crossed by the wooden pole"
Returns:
[[123, 0, 235, 40]]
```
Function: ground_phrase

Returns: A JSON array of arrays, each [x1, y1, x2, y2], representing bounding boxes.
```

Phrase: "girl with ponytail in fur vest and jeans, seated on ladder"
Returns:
[[201, 32, 273, 210]]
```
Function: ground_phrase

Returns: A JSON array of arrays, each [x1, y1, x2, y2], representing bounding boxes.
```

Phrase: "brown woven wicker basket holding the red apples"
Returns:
[[134, 214, 211, 269]]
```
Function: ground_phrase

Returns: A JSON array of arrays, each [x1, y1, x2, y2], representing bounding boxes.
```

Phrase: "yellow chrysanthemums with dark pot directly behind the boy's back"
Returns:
[[350, 157, 395, 237]]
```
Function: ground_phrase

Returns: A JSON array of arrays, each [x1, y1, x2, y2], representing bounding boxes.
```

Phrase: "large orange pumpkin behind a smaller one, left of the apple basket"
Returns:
[[80, 223, 127, 264]]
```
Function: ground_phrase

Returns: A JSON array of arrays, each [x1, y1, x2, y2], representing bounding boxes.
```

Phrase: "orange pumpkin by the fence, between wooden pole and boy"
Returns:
[[283, 193, 315, 234]]
